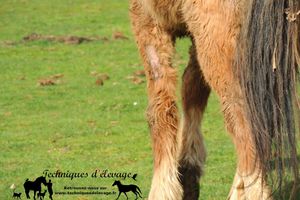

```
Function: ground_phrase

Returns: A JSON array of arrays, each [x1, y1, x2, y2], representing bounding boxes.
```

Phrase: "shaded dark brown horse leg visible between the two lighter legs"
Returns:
[[179, 46, 210, 199]]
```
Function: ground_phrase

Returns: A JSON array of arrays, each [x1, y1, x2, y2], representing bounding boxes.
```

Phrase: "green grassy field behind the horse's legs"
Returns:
[[0, 0, 235, 200]]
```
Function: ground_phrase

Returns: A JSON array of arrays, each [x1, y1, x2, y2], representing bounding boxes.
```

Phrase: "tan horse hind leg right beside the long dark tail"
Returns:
[[183, 0, 269, 200]]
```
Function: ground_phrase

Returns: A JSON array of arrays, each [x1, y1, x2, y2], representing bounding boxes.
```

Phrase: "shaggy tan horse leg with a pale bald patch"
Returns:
[[131, 1, 182, 200]]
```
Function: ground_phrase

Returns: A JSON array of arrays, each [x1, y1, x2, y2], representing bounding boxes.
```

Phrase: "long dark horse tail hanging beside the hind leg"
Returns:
[[235, 0, 300, 196]]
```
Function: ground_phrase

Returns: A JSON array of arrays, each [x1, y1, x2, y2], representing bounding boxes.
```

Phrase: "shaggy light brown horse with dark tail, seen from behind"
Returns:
[[130, 0, 300, 200]]
